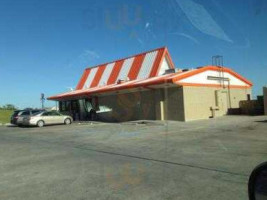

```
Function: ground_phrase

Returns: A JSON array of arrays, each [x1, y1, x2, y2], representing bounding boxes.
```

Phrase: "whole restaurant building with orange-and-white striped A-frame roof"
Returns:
[[48, 47, 252, 122]]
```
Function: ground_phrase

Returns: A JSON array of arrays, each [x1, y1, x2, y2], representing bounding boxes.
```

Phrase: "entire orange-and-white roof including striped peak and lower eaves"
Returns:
[[48, 48, 253, 101]]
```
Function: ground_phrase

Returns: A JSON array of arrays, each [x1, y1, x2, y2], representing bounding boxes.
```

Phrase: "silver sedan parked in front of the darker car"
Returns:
[[18, 111, 73, 127]]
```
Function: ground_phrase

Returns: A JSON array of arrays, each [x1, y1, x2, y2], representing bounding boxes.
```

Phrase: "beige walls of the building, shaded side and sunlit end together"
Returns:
[[82, 86, 251, 122]]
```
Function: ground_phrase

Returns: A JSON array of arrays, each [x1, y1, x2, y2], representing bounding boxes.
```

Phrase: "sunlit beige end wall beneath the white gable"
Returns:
[[183, 87, 251, 121]]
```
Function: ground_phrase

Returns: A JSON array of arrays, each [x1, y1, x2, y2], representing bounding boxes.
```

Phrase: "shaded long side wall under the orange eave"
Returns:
[[98, 87, 184, 122]]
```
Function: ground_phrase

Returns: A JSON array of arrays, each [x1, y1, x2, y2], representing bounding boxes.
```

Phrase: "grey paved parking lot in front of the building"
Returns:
[[0, 116, 267, 200]]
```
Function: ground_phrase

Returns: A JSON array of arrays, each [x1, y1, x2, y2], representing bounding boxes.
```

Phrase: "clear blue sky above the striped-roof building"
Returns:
[[0, 0, 267, 108]]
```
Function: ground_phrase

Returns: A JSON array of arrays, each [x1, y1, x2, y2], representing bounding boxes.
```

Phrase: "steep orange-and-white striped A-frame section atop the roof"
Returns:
[[76, 47, 174, 90]]
